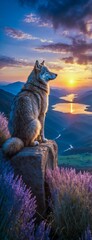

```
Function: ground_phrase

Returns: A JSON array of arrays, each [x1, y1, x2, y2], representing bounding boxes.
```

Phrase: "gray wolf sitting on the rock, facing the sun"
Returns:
[[3, 61, 57, 156]]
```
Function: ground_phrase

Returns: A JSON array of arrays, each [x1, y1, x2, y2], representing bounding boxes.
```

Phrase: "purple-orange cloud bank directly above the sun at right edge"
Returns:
[[36, 38, 92, 65]]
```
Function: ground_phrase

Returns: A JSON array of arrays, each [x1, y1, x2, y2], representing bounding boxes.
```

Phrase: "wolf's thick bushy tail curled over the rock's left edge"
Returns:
[[2, 137, 24, 157]]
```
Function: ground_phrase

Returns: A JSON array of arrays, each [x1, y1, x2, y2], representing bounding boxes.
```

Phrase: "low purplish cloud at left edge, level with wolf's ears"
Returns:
[[0, 56, 32, 69]]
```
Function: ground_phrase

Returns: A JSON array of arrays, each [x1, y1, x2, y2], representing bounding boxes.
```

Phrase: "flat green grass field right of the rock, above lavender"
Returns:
[[58, 153, 92, 171]]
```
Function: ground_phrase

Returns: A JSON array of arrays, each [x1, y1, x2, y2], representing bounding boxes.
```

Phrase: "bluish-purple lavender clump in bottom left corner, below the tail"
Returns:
[[0, 159, 49, 240]]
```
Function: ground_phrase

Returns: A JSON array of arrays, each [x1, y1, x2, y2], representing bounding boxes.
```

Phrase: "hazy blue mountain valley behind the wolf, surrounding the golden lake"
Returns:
[[0, 82, 92, 169]]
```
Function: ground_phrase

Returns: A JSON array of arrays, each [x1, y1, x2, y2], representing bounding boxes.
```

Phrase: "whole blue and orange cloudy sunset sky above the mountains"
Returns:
[[0, 0, 92, 87]]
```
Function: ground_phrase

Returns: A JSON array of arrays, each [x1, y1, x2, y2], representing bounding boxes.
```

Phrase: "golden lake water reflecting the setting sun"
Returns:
[[52, 94, 92, 114]]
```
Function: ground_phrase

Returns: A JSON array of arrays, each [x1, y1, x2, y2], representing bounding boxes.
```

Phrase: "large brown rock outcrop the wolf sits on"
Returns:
[[1, 140, 57, 215]]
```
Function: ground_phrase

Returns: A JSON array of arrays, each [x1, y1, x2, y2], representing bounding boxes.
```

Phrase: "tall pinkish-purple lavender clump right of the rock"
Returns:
[[46, 167, 92, 240]]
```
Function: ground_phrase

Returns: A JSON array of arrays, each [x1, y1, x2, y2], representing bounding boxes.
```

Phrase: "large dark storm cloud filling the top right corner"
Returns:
[[19, 0, 92, 33]]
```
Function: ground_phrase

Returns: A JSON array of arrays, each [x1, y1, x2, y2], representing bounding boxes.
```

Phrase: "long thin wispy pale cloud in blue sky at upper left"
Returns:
[[5, 27, 52, 43]]
